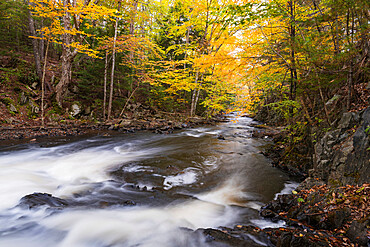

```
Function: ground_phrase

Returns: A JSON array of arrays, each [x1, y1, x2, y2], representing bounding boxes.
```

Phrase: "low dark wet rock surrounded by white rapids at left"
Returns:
[[19, 193, 69, 209]]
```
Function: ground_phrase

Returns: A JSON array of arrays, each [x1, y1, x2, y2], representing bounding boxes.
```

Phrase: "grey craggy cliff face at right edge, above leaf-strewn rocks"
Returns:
[[310, 107, 370, 186]]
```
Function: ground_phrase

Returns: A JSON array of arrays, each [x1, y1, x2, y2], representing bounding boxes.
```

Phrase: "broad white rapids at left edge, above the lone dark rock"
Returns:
[[0, 144, 163, 209]]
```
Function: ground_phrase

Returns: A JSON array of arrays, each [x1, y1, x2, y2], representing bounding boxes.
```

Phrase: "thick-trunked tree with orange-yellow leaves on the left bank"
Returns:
[[30, 0, 115, 106]]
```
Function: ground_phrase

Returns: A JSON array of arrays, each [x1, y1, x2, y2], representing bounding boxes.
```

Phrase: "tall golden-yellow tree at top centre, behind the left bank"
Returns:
[[149, 0, 252, 116]]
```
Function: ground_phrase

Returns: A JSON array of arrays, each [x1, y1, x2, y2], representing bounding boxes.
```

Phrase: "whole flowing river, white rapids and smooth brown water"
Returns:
[[0, 116, 296, 247]]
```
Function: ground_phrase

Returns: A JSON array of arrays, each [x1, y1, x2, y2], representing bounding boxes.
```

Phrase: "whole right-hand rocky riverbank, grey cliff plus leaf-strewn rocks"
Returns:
[[241, 107, 370, 247]]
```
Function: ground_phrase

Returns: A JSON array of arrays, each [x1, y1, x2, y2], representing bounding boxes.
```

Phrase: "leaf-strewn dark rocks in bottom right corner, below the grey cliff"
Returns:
[[260, 183, 370, 246]]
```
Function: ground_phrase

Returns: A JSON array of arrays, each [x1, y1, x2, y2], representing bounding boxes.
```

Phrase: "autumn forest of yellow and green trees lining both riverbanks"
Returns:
[[0, 0, 370, 171]]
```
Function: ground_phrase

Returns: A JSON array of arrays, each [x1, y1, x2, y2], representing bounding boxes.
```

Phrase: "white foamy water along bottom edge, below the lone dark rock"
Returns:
[[35, 201, 237, 247]]
